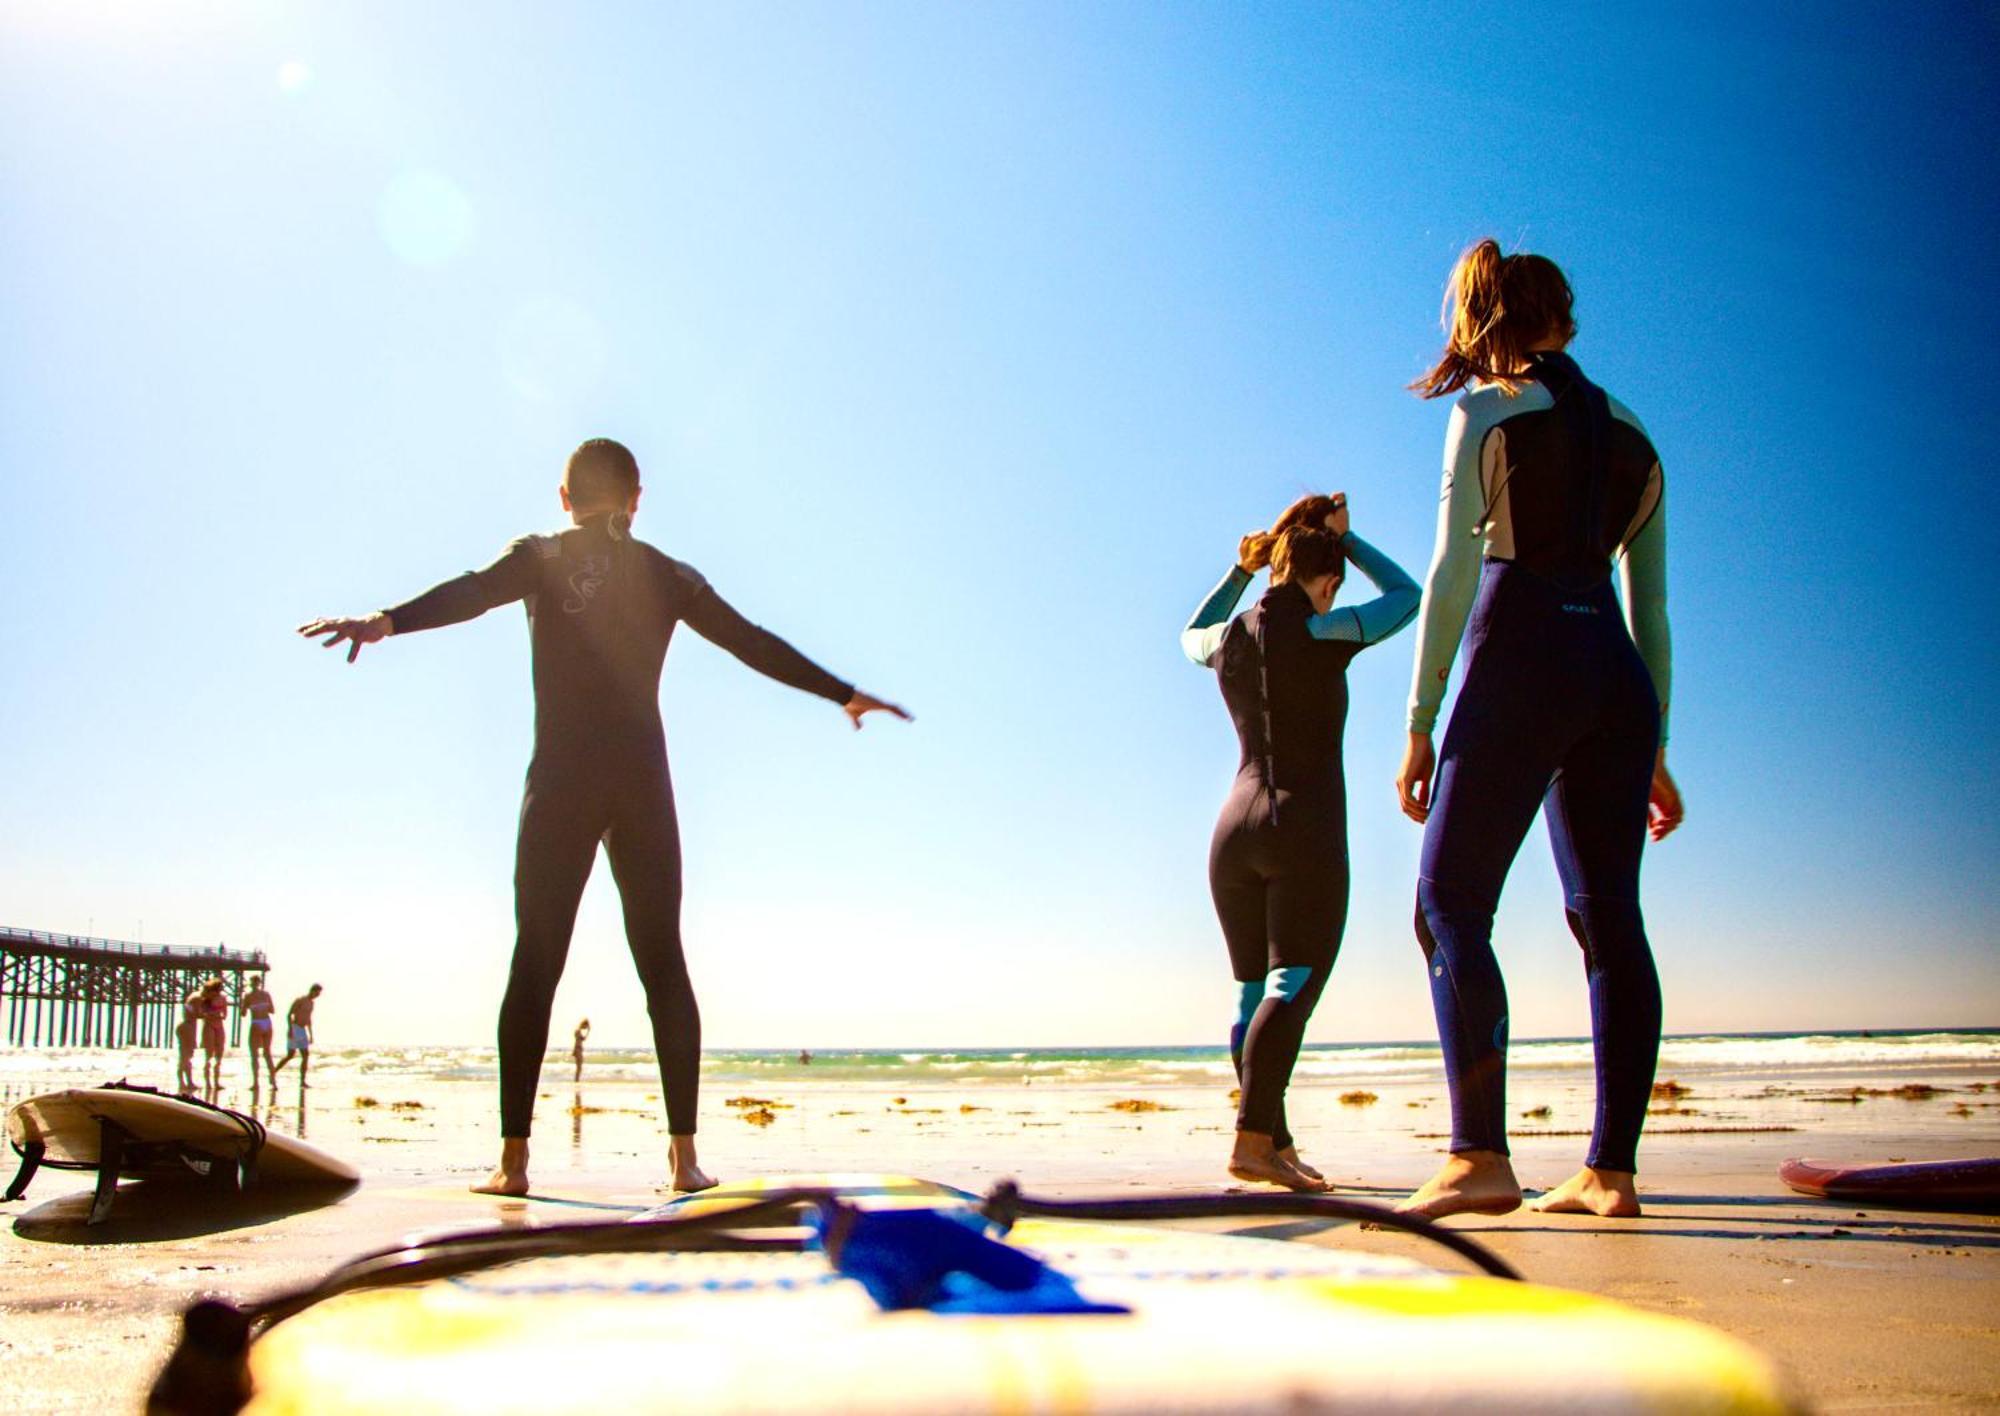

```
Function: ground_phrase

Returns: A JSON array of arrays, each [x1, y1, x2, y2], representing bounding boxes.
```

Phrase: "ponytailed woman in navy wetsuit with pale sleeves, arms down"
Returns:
[[1396, 240, 1682, 1218]]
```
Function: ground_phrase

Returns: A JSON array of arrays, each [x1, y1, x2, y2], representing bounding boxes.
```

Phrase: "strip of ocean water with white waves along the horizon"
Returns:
[[0, 1028, 2000, 1090]]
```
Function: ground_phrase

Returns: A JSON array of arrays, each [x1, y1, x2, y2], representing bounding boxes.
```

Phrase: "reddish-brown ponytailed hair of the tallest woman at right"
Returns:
[[1410, 236, 1576, 398]]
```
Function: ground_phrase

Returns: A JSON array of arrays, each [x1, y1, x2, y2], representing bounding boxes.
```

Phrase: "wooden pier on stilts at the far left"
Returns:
[[0, 924, 268, 1048]]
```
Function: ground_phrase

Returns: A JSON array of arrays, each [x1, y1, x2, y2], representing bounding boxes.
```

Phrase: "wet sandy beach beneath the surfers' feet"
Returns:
[[0, 1054, 2000, 1412]]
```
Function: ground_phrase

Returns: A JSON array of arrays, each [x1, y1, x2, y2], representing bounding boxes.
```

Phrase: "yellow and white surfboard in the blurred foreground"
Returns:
[[246, 1176, 1798, 1416]]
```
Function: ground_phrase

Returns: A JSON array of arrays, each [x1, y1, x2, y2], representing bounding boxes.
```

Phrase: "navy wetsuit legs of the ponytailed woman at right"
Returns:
[[1418, 562, 1660, 1170]]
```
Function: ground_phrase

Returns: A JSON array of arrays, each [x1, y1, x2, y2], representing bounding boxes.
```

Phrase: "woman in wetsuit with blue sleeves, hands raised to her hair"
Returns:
[[1180, 492, 1418, 1190]]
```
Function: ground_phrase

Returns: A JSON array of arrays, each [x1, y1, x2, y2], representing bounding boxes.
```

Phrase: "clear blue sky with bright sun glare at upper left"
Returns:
[[0, 0, 2000, 1046]]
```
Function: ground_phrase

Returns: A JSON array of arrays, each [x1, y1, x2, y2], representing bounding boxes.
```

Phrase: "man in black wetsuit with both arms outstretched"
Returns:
[[300, 438, 910, 1194]]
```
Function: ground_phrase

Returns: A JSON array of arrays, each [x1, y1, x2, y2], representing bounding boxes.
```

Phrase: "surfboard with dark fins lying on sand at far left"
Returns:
[[6, 1084, 360, 1224]]
